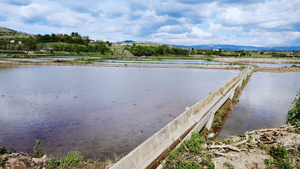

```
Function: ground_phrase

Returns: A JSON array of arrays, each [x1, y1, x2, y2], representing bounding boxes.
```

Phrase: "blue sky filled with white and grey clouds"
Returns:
[[0, 0, 300, 46]]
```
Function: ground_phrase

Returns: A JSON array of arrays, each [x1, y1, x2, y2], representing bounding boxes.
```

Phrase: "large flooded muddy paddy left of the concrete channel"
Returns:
[[0, 66, 240, 160]]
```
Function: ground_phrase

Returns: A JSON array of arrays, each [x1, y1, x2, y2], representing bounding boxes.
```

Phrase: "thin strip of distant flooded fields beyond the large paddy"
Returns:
[[0, 56, 300, 68]]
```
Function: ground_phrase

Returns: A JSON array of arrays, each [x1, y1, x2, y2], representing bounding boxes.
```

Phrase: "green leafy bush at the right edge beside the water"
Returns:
[[286, 89, 300, 124]]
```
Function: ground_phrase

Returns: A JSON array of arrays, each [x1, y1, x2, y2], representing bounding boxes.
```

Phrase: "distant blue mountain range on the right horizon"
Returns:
[[170, 44, 300, 52]]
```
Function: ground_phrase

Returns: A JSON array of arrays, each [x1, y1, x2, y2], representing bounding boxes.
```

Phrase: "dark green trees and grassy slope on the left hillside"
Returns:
[[0, 32, 112, 54]]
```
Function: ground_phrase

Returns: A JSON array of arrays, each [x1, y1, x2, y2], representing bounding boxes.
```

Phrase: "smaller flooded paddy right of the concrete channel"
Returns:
[[219, 72, 300, 138]]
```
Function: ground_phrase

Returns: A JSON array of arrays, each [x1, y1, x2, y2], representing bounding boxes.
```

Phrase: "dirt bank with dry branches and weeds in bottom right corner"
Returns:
[[162, 124, 300, 169]]
